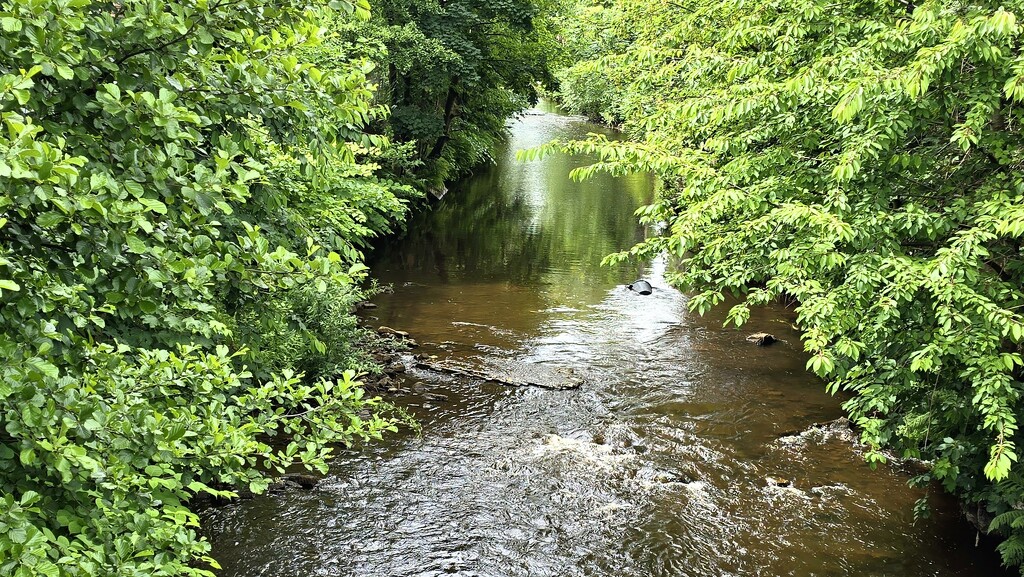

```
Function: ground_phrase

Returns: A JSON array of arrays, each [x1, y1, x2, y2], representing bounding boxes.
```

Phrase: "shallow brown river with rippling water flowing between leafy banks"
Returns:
[[204, 101, 1002, 577]]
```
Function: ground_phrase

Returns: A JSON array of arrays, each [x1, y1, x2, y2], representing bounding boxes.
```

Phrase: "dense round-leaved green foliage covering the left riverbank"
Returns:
[[0, 0, 415, 577]]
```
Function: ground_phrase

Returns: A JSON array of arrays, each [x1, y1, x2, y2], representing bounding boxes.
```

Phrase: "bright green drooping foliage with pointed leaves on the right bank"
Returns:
[[527, 0, 1024, 565]]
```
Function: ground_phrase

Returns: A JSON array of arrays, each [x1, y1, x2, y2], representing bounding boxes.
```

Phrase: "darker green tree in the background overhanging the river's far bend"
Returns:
[[333, 0, 560, 187]]
